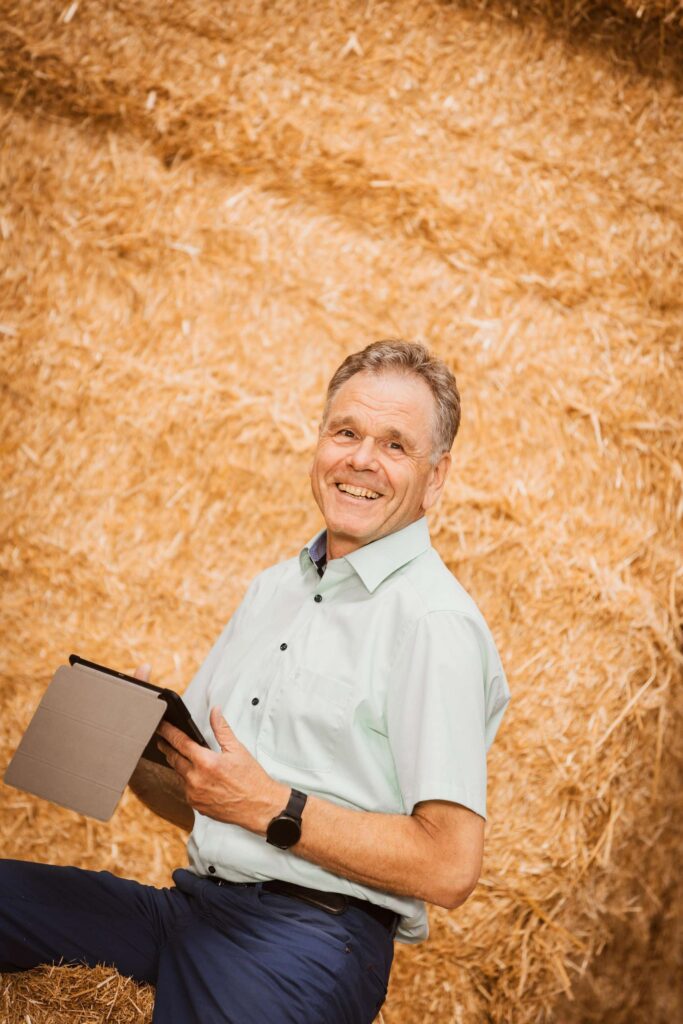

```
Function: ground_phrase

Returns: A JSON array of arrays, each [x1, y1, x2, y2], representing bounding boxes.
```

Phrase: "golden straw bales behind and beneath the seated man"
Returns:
[[0, 0, 683, 1024]]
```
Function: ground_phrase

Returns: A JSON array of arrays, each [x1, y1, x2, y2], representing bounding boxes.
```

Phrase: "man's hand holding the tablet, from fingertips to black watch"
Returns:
[[158, 708, 290, 835]]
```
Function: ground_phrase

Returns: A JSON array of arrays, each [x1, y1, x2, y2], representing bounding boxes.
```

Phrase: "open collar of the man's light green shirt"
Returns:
[[299, 516, 431, 594]]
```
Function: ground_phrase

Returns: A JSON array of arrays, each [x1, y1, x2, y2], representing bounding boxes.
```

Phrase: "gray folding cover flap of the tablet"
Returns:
[[4, 665, 166, 821]]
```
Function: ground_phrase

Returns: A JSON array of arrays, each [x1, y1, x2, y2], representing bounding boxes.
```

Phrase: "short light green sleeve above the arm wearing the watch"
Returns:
[[387, 610, 509, 818]]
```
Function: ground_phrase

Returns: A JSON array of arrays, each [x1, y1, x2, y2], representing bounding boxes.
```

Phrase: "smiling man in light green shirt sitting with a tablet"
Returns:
[[0, 342, 509, 1024]]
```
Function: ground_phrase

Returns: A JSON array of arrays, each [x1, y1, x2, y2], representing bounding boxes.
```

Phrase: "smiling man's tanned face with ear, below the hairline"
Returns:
[[310, 371, 451, 558]]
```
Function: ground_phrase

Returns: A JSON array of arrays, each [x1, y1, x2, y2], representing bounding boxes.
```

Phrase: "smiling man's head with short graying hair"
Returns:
[[310, 341, 460, 558]]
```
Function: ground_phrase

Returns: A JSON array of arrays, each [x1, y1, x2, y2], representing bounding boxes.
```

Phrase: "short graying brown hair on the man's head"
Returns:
[[323, 338, 460, 462]]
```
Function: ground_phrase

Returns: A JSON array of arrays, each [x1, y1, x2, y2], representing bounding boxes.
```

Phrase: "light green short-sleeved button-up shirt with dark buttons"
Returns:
[[185, 518, 510, 942]]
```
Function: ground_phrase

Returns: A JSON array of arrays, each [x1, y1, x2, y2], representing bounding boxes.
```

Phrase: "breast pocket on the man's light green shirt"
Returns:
[[258, 669, 353, 772]]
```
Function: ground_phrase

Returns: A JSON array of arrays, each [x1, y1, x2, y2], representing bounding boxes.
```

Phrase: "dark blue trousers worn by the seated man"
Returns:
[[0, 860, 393, 1024]]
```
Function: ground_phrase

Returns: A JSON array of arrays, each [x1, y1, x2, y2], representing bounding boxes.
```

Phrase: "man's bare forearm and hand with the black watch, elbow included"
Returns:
[[159, 708, 484, 908]]
